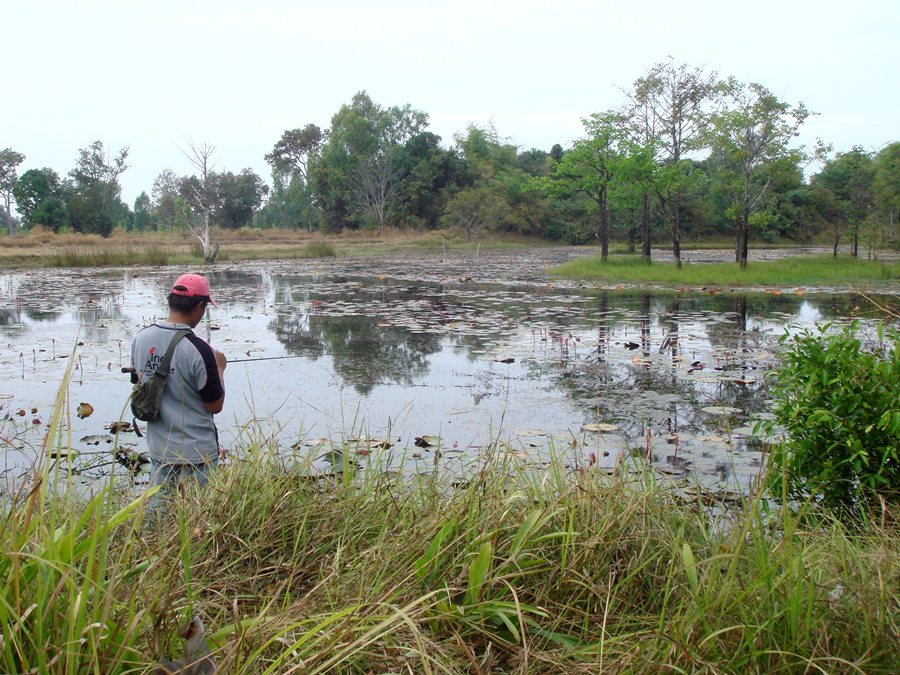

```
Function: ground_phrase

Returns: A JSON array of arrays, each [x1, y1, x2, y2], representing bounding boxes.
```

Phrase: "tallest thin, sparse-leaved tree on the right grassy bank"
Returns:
[[629, 61, 716, 267]]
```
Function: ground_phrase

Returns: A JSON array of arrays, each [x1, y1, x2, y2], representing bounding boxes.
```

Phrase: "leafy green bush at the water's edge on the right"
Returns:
[[771, 325, 900, 508]]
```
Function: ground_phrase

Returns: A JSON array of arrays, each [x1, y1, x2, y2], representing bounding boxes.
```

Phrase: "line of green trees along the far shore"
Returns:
[[0, 61, 900, 265]]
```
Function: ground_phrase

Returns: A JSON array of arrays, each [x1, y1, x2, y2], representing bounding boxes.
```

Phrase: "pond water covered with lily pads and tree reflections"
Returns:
[[0, 249, 888, 489]]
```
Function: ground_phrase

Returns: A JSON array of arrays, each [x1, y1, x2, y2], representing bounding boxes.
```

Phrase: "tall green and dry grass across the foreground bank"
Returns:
[[0, 394, 900, 673]]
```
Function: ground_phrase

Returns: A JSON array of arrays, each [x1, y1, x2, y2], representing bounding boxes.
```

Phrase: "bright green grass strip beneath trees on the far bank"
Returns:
[[551, 255, 900, 287]]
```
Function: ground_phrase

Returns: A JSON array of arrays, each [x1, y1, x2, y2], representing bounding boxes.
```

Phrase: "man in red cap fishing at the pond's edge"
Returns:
[[131, 274, 227, 490]]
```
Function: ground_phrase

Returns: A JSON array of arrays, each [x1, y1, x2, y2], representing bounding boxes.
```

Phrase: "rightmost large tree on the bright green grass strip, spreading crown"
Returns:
[[706, 78, 809, 268]]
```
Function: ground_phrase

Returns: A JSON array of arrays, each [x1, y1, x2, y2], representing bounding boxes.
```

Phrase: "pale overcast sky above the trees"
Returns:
[[7, 0, 900, 205]]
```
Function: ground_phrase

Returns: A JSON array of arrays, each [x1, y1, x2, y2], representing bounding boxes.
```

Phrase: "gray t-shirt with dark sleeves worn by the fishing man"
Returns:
[[131, 321, 225, 464]]
